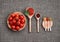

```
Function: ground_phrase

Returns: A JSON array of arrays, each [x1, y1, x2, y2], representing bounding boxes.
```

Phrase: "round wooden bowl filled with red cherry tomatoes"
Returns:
[[7, 12, 26, 31]]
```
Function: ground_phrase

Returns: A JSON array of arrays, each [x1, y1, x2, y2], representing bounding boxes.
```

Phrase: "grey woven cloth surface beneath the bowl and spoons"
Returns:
[[0, 0, 60, 42]]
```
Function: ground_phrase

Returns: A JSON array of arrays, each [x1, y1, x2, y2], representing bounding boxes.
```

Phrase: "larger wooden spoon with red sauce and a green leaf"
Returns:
[[25, 7, 34, 32]]
